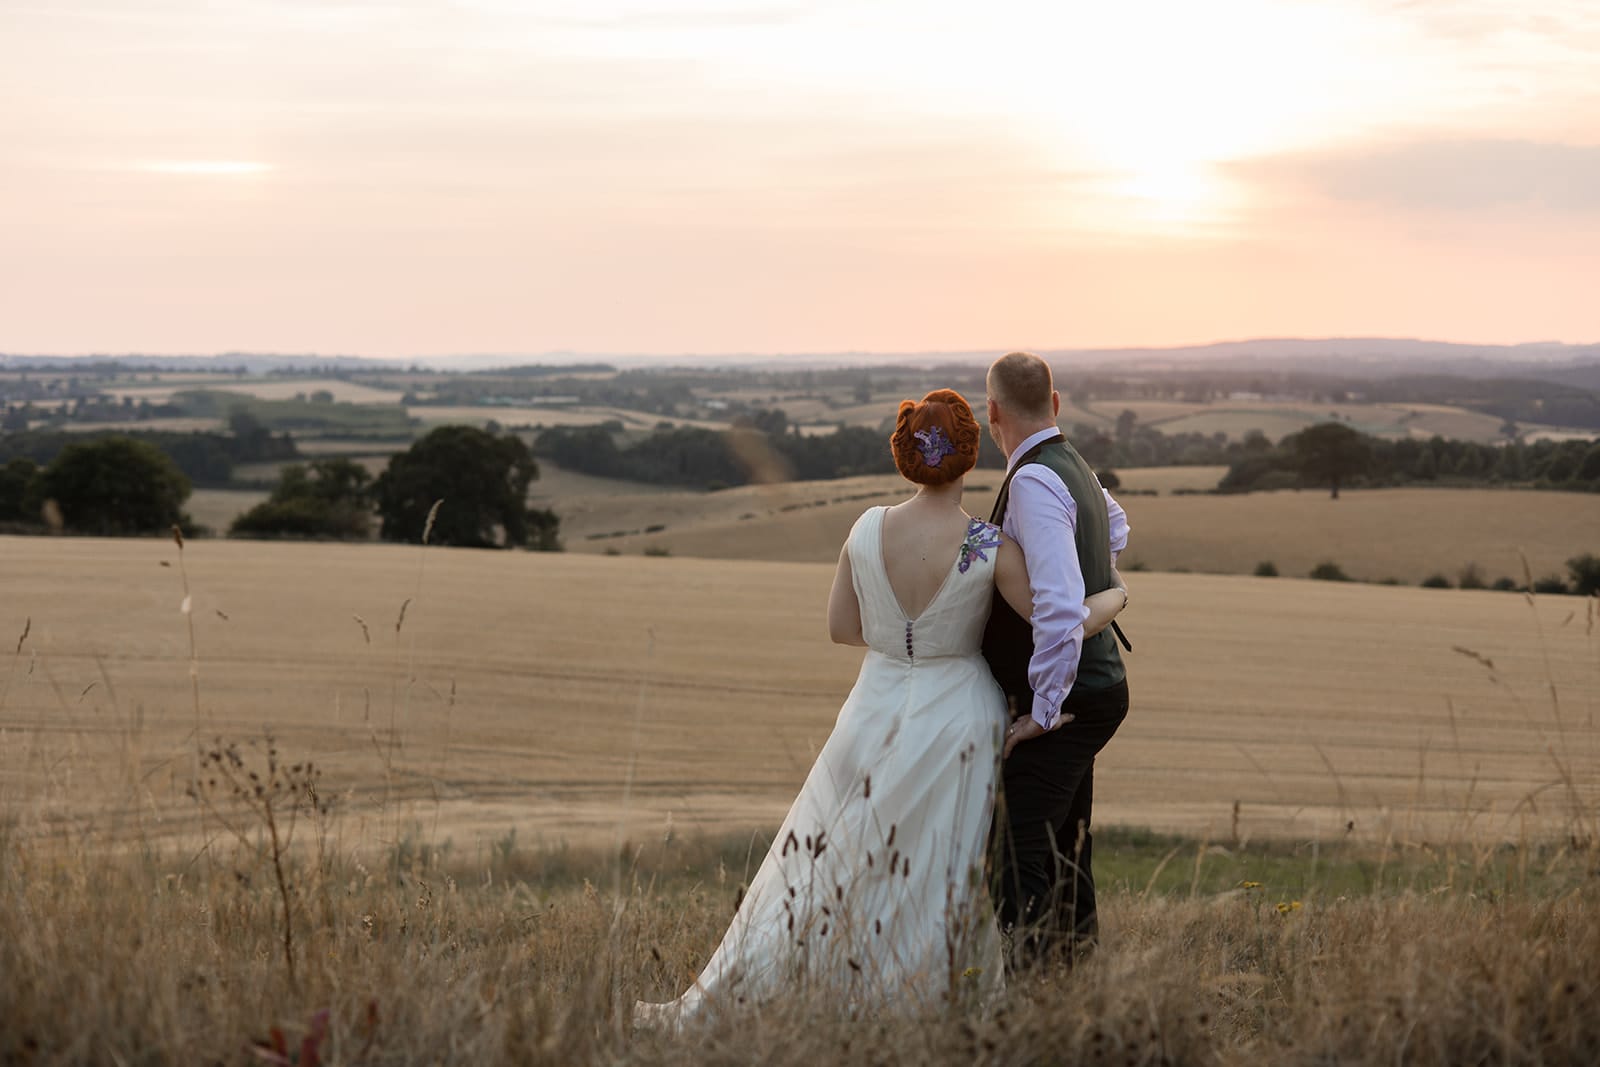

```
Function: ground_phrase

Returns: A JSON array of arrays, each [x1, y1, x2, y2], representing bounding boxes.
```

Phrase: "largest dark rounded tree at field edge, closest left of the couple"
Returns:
[[373, 426, 554, 549]]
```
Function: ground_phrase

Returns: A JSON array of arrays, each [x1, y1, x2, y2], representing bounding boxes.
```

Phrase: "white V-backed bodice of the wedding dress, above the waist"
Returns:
[[848, 507, 1000, 662]]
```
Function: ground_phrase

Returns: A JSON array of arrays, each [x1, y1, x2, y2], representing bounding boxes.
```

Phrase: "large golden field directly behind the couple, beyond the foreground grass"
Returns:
[[0, 537, 1600, 848]]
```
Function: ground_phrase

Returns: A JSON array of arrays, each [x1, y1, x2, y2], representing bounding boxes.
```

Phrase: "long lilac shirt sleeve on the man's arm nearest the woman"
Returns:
[[1005, 464, 1088, 729]]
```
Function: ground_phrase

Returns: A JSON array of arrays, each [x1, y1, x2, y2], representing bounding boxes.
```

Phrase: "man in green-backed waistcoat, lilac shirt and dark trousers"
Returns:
[[984, 352, 1128, 965]]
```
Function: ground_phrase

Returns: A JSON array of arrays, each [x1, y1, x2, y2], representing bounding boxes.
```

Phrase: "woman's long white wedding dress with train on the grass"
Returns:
[[634, 507, 1006, 1025]]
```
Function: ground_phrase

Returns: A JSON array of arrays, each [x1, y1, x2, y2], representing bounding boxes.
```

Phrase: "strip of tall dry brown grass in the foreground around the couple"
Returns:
[[0, 838, 1600, 1065]]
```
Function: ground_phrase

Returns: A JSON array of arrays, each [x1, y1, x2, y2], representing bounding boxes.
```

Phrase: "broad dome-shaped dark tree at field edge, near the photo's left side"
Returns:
[[38, 437, 190, 536]]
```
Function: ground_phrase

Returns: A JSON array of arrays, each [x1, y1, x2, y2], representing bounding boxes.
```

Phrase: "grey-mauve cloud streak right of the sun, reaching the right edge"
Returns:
[[1232, 139, 1600, 213]]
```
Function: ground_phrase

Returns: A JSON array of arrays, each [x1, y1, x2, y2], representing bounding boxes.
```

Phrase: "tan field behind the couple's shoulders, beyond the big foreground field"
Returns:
[[557, 483, 1600, 584]]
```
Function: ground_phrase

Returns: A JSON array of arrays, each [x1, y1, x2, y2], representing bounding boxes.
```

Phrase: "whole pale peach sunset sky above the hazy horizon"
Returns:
[[0, 0, 1600, 357]]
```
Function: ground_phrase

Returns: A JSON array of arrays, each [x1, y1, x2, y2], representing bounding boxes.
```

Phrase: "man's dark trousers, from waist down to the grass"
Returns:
[[994, 681, 1128, 966]]
